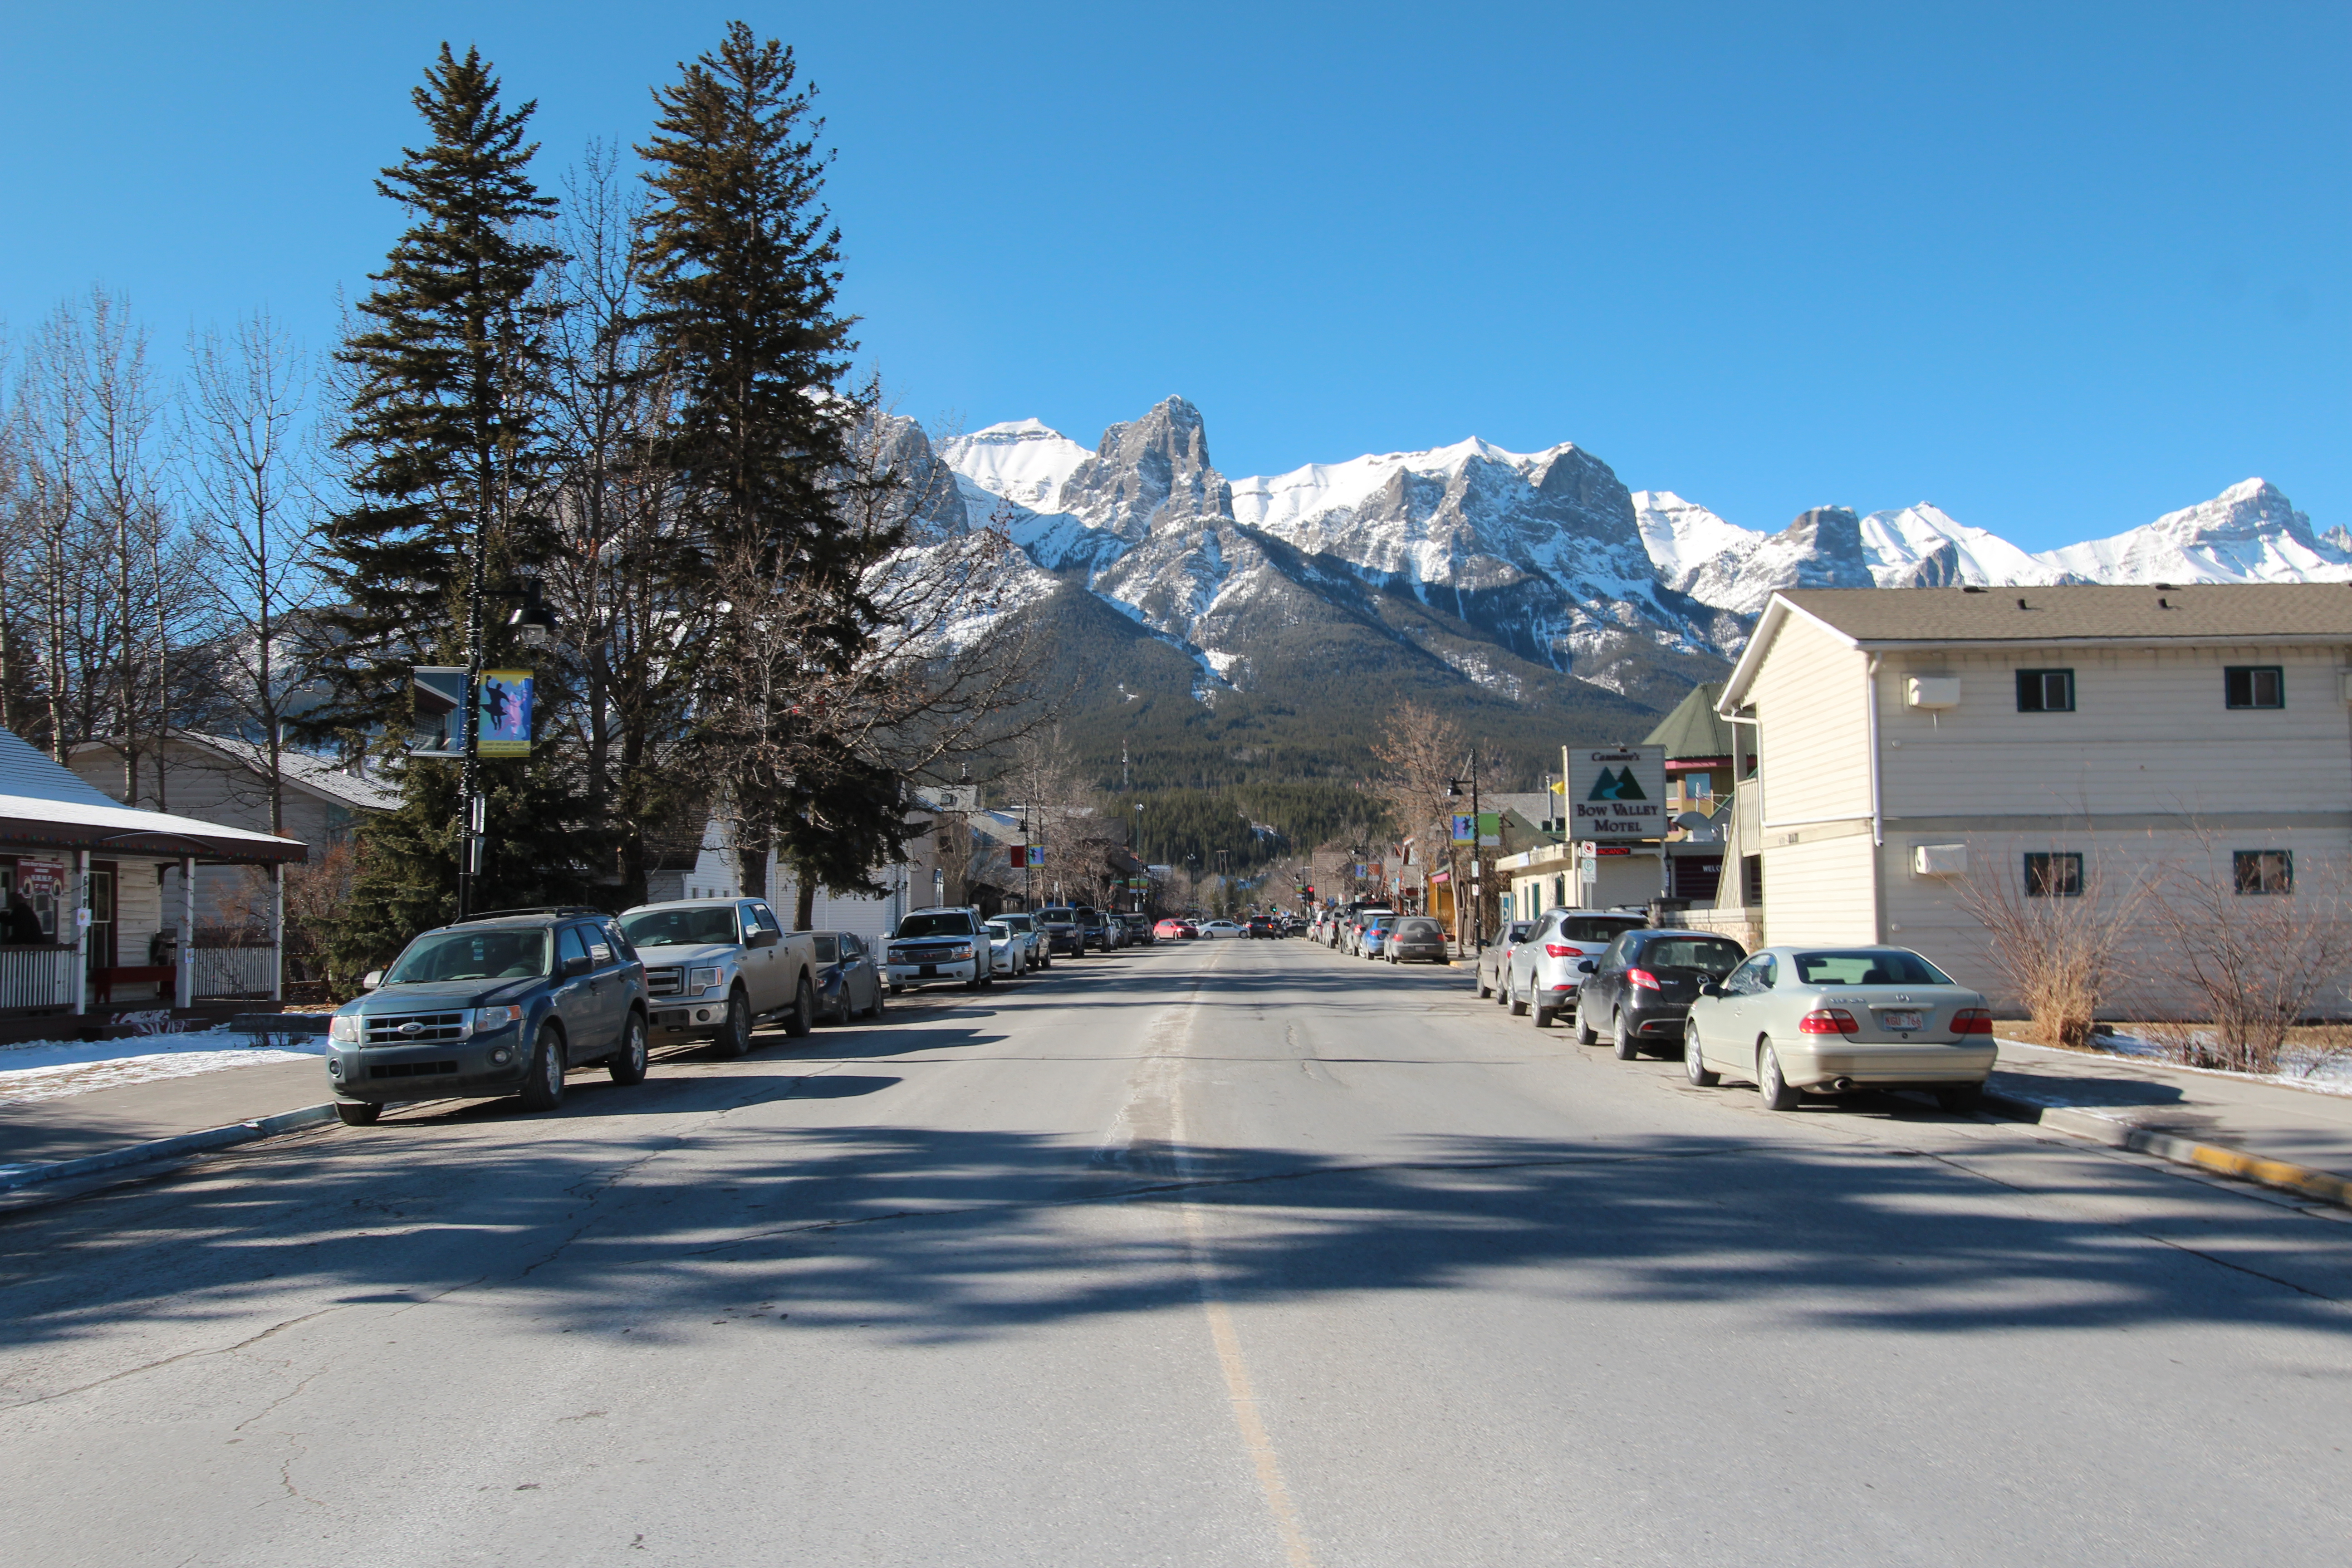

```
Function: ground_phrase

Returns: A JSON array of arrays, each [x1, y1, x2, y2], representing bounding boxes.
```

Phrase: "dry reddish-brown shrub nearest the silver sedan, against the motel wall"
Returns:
[[1959, 853, 2147, 1051]]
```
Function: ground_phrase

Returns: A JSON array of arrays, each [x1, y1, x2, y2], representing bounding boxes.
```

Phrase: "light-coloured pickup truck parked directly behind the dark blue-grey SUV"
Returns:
[[621, 898, 816, 1055]]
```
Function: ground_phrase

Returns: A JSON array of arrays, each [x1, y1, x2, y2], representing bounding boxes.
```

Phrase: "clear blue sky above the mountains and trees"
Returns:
[[0, 0, 2352, 548]]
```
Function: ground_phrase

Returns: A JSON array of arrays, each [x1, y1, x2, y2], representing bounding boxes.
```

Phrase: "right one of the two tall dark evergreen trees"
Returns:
[[637, 21, 906, 926]]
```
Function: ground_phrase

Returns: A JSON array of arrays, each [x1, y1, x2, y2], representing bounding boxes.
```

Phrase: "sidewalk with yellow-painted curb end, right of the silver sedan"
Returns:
[[1985, 1039, 2352, 1204]]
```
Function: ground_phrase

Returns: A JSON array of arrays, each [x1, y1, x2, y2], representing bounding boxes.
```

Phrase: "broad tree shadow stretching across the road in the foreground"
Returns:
[[0, 1086, 2347, 1347]]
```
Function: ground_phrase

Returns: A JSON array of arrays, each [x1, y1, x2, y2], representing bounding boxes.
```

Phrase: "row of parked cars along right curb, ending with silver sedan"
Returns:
[[1472, 907, 1997, 1112]]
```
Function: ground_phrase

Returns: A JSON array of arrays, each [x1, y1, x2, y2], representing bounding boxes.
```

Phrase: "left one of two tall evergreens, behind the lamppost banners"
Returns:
[[310, 44, 586, 961]]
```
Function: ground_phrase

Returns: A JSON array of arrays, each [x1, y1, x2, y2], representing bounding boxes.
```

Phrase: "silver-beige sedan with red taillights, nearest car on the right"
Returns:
[[1682, 947, 1997, 1112]]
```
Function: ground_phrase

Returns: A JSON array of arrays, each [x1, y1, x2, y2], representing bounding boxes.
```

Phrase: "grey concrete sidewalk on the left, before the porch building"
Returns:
[[0, 1055, 334, 1168]]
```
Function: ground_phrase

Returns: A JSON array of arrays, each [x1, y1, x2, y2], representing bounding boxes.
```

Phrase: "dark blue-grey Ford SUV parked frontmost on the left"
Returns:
[[327, 910, 647, 1126]]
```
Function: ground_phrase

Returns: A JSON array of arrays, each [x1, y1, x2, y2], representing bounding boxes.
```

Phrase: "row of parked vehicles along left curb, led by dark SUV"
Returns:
[[327, 898, 1176, 1126]]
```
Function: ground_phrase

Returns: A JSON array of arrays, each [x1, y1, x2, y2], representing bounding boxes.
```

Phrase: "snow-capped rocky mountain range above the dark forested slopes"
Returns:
[[936, 397, 2352, 747]]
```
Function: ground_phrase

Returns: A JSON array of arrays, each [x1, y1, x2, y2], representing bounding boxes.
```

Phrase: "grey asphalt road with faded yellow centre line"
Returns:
[[0, 941, 2352, 1568]]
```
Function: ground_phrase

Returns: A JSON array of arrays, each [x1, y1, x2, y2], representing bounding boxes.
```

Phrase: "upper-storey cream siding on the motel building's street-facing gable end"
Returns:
[[1750, 616, 1870, 832]]
